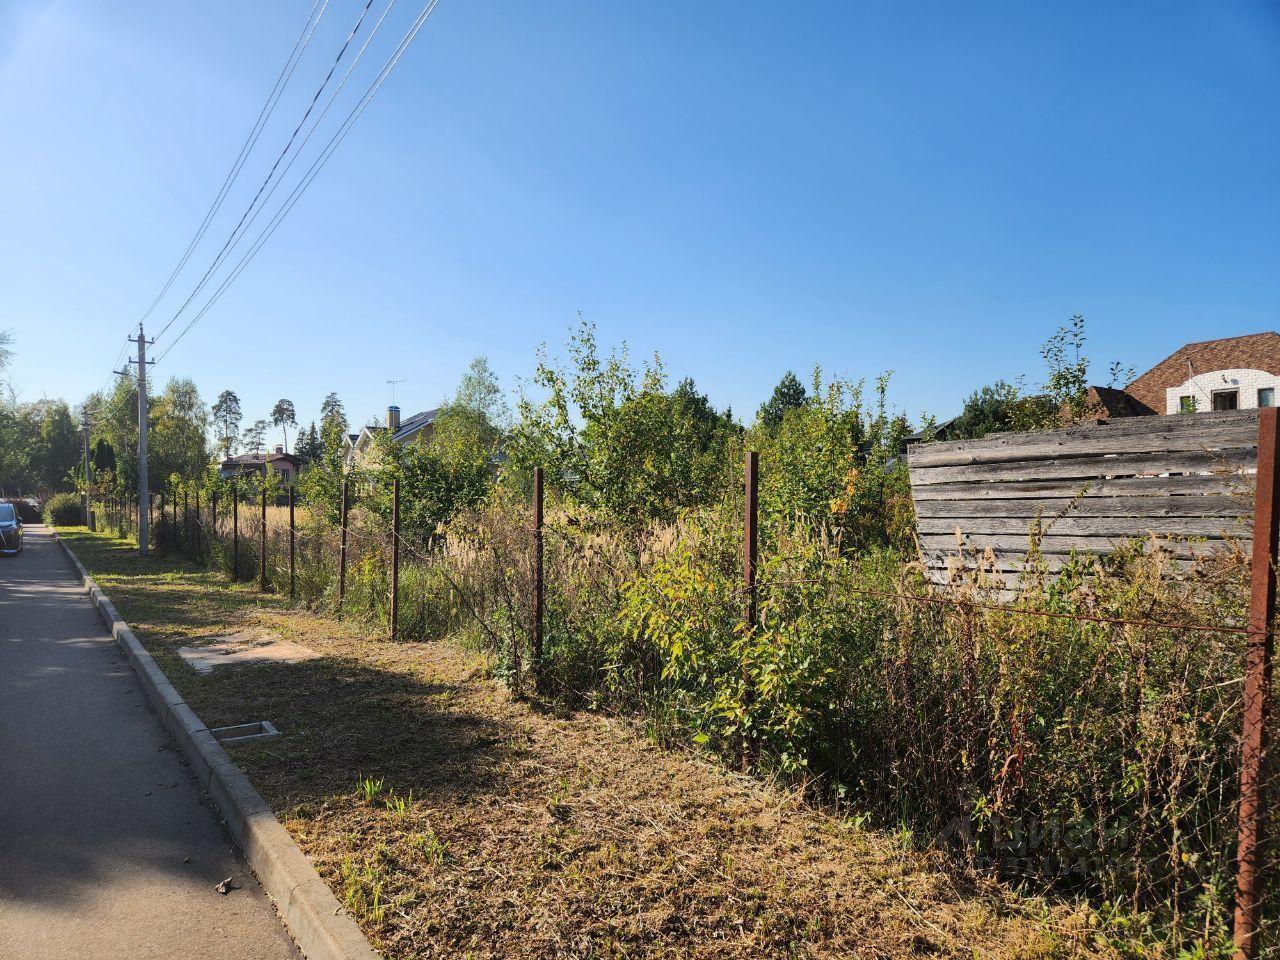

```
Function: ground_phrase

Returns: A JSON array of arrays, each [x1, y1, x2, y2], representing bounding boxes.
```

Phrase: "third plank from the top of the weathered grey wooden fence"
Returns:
[[911, 474, 1253, 506]]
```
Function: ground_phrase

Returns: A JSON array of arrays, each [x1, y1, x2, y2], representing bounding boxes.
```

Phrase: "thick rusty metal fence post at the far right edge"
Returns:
[[1235, 407, 1280, 960]]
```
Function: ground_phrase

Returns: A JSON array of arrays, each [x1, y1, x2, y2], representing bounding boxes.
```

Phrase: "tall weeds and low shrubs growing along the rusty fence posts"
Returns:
[[97, 453, 1280, 956]]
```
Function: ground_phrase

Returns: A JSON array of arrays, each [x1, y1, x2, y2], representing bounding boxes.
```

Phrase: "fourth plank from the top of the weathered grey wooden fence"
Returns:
[[915, 494, 1253, 520]]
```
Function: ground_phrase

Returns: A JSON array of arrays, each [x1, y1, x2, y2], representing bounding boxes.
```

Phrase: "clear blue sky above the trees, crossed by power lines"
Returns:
[[0, 0, 1280, 432]]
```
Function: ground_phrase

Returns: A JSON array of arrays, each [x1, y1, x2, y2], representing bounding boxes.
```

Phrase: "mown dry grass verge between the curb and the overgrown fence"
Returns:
[[60, 529, 1105, 960]]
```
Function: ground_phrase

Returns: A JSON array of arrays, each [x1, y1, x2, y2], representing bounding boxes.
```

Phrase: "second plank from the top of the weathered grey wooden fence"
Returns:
[[910, 448, 1257, 486]]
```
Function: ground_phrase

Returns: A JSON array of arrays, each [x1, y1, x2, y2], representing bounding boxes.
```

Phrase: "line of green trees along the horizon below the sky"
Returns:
[[0, 316, 1132, 514]]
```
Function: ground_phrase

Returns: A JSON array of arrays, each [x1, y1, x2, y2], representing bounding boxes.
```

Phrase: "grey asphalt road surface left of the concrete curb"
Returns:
[[0, 526, 301, 960]]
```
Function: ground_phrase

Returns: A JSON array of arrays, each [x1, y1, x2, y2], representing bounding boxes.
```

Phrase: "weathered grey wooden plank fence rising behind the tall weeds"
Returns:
[[908, 411, 1258, 581]]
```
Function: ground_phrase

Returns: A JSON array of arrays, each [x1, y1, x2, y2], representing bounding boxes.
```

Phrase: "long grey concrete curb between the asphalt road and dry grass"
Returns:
[[51, 530, 381, 960]]
